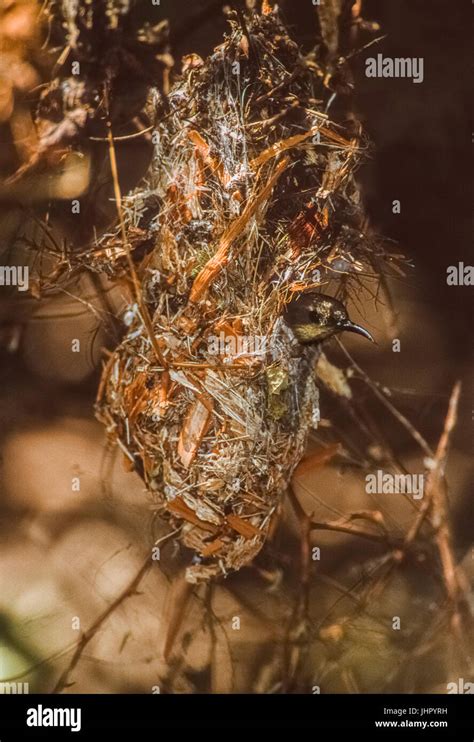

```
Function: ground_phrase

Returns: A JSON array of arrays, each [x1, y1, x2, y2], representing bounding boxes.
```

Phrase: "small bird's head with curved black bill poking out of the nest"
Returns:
[[283, 291, 375, 345]]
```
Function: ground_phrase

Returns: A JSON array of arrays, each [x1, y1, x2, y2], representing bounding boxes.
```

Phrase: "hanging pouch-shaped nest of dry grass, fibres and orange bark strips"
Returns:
[[97, 7, 384, 583]]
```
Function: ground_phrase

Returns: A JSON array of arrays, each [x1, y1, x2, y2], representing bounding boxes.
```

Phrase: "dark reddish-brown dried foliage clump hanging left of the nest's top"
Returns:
[[26, 0, 172, 175]]
